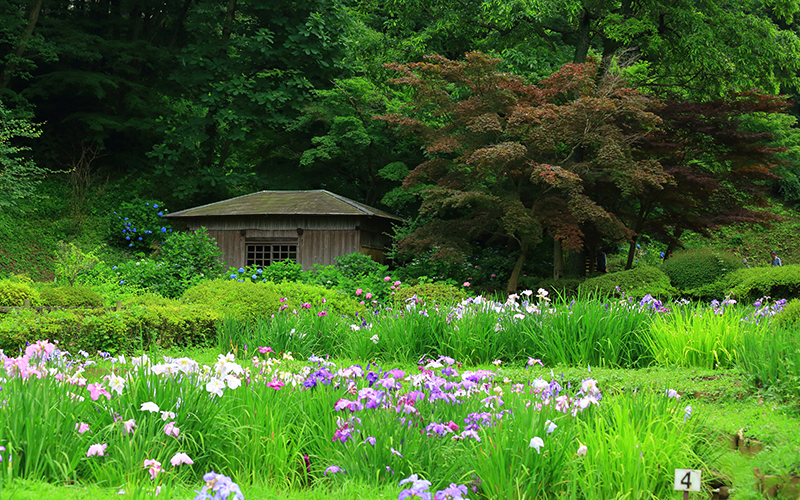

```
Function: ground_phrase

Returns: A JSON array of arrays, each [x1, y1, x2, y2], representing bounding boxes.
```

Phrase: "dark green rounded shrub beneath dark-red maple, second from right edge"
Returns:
[[661, 247, 744, 290]]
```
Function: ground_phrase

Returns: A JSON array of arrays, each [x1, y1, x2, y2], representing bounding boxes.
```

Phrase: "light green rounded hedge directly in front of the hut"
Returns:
[[181, 280, 364, 321]]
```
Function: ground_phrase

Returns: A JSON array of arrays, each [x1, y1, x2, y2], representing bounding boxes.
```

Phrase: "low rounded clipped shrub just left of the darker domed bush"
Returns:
[[578, 266, 675, 298]]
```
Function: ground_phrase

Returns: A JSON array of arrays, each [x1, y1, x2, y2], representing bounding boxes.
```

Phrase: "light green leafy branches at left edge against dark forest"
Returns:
[[0, 102, 48, 208]]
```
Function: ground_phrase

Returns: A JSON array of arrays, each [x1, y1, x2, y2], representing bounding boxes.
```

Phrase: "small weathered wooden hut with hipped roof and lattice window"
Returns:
[[166, 190, 401, 269]]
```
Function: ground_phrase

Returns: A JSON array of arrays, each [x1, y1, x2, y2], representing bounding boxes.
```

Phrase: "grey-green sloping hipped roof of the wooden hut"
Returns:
[[165, 189, 401, 221]]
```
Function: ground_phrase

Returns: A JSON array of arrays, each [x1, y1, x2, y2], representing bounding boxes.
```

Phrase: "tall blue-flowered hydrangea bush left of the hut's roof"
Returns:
[[108, 198, 172, 252]]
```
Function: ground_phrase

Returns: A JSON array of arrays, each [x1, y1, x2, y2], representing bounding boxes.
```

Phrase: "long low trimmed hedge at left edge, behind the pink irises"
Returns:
[[0, 306, 217, 354]]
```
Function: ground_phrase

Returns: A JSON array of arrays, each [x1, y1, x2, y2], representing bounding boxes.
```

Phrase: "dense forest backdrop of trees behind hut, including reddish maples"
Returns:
[[0, 0, 800, 289]]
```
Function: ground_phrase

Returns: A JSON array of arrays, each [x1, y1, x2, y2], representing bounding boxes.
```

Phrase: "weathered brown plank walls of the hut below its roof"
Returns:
[[186, 216, 391, 270]]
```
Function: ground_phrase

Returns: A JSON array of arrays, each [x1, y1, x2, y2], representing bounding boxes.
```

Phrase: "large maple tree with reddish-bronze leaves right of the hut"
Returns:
[[377, 52, 672, 291]]
